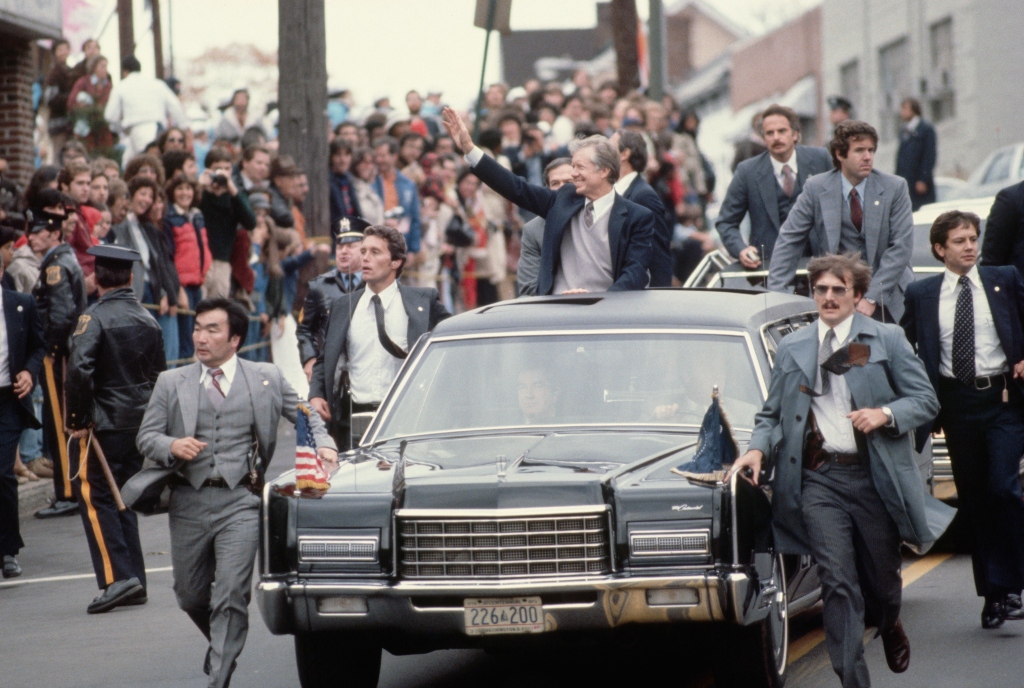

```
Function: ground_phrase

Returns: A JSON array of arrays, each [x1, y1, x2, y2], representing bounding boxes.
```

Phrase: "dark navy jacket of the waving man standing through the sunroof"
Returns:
[[473, 156, 654, 296]]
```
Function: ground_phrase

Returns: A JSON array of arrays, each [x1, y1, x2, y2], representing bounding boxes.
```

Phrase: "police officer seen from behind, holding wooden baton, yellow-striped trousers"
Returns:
[[67, 246, 167, 614]]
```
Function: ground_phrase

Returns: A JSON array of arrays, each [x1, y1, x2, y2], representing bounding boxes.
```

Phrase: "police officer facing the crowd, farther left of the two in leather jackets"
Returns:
[[29, 211, 87, 518]]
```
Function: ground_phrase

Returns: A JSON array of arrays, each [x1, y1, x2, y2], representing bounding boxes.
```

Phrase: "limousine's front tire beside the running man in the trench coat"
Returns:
[[712, 554, 790, 688]]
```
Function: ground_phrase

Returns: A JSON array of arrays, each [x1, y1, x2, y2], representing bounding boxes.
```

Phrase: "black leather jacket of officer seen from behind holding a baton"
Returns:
[[65, 287, 167, 431]]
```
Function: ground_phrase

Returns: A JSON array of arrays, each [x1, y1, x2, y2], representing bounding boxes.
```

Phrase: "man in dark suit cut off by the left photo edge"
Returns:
[[0, 227, 46, 578]]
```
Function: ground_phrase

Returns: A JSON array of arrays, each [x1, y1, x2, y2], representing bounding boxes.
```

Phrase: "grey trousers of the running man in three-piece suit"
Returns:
[[170, 486, 260, 688]]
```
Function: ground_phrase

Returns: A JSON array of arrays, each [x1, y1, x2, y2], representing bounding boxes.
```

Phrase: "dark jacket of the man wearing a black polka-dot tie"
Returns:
[[900, 265, 1024, 450]]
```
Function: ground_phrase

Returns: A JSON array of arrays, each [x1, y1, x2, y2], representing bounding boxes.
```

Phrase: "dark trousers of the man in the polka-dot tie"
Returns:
[[939, 378, 1024, 597]]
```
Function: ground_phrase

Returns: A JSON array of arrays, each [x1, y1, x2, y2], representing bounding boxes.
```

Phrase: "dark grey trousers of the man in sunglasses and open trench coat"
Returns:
[[802, 463, 903, 688]]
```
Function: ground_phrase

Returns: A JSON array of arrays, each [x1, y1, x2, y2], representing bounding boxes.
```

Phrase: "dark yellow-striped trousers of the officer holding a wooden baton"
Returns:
[[70, 431, 145, 589]]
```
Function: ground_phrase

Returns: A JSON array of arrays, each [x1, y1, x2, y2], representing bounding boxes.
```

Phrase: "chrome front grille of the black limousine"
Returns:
[[396, 512, 611, 578]]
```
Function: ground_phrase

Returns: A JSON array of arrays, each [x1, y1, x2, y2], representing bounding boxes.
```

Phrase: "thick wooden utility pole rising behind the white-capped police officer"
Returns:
[[278, 0, 329, 237]]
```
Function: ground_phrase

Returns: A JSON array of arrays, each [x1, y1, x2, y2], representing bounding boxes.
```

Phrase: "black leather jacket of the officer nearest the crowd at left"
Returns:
[[32, 244, 88, 357]]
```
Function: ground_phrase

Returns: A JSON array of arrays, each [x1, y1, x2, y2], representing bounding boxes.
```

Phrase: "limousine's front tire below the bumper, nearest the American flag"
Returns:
[[295, 633, 381, 688]]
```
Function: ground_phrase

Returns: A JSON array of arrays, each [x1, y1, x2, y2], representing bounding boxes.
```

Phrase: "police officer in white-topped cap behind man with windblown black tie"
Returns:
[[295, 217, 370, 380]]
